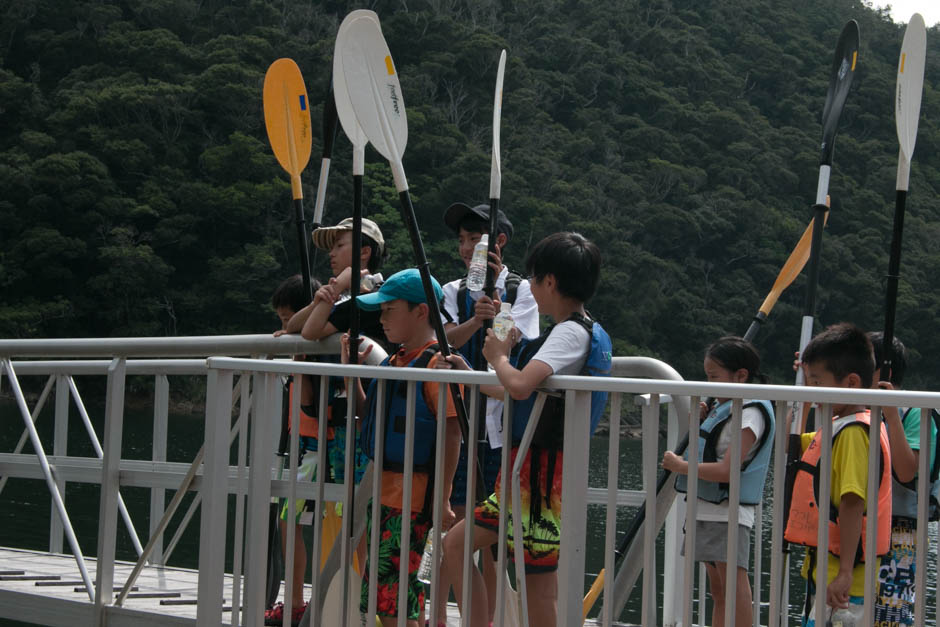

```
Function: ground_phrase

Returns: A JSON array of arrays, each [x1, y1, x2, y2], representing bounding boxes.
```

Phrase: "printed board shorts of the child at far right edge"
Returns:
[[875, 517, 917, 627]]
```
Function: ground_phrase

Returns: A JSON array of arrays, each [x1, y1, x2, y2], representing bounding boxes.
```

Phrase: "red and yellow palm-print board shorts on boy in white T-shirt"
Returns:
[[474, 447, 562, 574]]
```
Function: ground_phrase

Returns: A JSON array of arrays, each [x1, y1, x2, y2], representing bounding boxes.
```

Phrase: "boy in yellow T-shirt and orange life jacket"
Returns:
[[784, 323, 891, 627]]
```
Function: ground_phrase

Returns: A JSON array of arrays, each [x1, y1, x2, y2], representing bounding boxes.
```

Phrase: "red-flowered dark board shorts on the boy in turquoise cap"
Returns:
[[359, 500, 431, 620]]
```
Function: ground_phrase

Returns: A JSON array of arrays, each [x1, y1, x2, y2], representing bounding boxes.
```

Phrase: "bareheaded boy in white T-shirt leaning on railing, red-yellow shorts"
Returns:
[[441, 233, 611, 627]]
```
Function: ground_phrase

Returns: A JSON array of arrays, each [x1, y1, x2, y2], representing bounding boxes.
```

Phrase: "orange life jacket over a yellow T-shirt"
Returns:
[[784, 410, 891, 564]]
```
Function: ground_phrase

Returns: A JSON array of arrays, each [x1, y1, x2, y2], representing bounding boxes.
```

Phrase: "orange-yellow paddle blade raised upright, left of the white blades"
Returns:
[[263, 59, 312, 198]]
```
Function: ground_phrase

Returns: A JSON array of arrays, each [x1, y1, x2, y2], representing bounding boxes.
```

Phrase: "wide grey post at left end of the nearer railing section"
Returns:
[[196, 369, 233, 627]]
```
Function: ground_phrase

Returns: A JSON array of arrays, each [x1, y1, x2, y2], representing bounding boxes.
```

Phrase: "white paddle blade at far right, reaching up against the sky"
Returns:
[[894, 13, 927, 162]]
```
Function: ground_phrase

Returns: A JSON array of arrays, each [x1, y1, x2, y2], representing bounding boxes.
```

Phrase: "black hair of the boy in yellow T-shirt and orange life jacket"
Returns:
[[802, 322, 875, 388]]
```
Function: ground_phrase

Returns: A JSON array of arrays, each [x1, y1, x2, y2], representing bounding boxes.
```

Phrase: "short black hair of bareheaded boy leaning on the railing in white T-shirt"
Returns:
[[525, 231, 601, 303]]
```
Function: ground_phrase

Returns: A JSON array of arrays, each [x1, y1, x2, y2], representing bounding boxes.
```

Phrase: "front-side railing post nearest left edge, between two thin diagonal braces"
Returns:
[[95, 357, 127, 626]]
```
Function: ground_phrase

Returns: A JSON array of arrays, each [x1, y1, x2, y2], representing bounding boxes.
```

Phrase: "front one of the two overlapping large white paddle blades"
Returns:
[[337, 17, 408, 168]]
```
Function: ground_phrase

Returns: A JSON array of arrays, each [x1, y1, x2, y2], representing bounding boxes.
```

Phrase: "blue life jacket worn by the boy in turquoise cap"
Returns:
[[359, 344, 440, 472]]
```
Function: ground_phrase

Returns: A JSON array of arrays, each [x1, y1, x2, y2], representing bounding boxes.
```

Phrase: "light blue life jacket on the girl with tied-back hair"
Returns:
[[676, 400, 774, 505]]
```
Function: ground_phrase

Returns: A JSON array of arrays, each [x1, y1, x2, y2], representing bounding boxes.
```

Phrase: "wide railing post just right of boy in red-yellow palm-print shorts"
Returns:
[[558, 390, 591, 625]]
